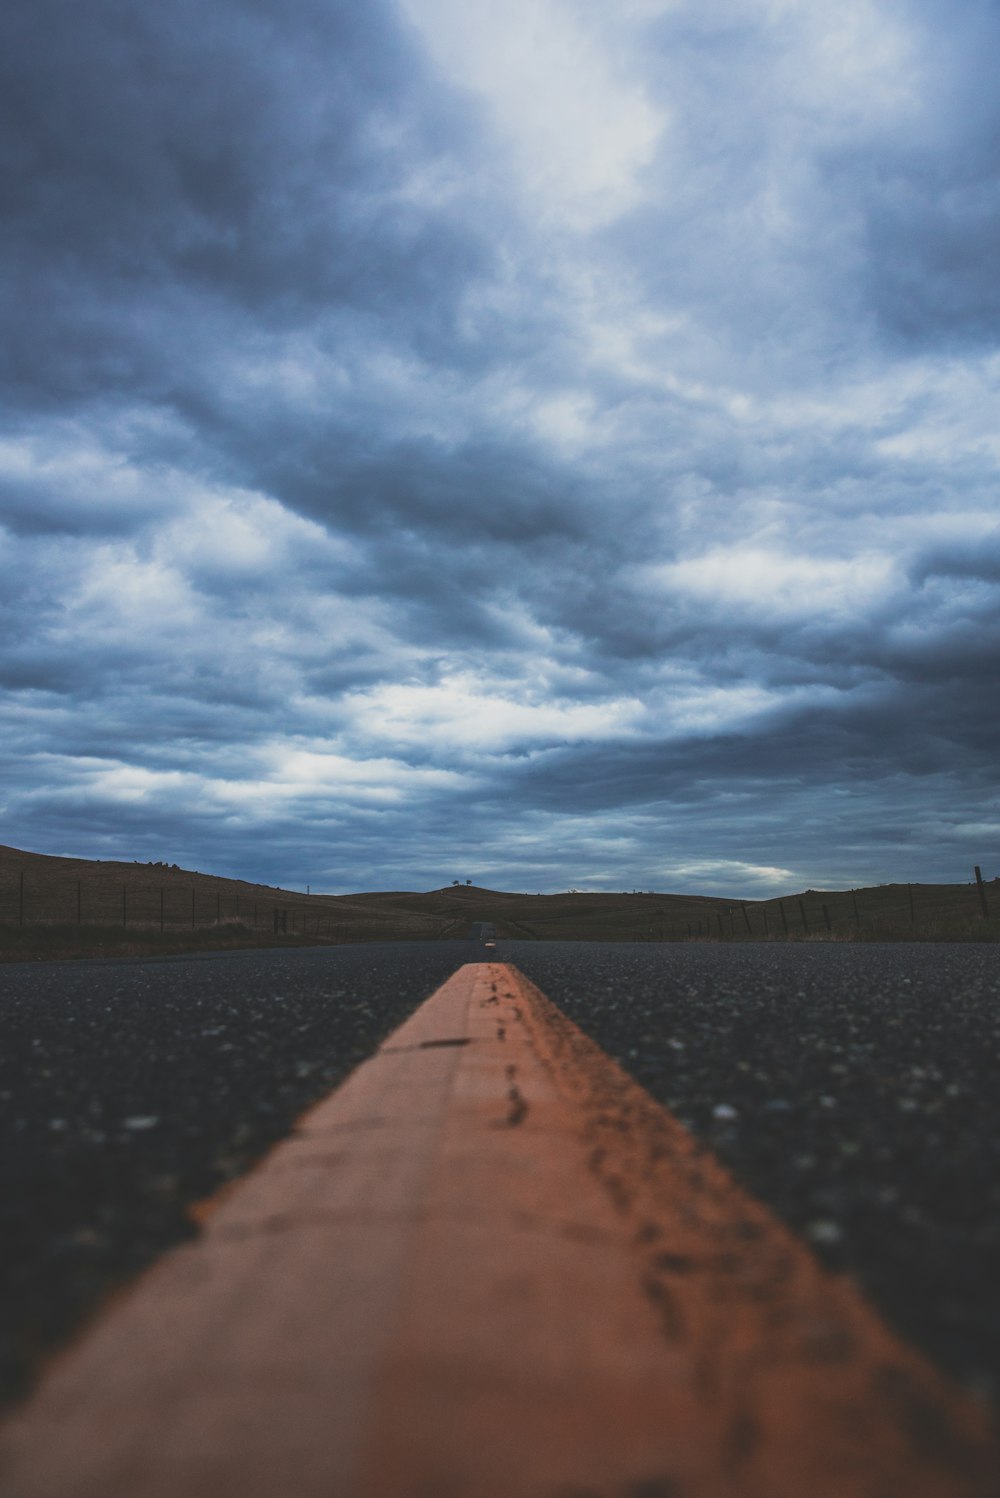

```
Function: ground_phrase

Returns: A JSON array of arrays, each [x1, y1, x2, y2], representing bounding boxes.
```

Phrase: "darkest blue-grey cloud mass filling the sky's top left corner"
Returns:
[[0, 0, 490, 416]]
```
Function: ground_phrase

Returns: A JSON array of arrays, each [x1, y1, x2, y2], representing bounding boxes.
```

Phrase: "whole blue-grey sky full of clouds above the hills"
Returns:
[[0, 0, 1000, 896]]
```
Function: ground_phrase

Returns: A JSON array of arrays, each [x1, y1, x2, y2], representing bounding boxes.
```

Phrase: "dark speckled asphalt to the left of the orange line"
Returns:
[[0, 942, 479, 1399]]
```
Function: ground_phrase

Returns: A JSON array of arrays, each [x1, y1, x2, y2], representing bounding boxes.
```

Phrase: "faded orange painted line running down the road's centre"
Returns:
[[0, 963, 996, 1498]]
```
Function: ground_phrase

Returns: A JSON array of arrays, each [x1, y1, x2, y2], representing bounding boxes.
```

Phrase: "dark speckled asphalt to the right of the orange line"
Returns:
[[497, 941, 1000, 1401]]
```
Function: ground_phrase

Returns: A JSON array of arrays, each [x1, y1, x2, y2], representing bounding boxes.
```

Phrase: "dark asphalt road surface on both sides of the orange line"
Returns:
[[0, 941, 1000, 1414]]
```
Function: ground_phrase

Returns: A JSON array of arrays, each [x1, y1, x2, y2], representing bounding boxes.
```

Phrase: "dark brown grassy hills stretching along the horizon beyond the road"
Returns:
[[0, 846, 1000, 960]]
